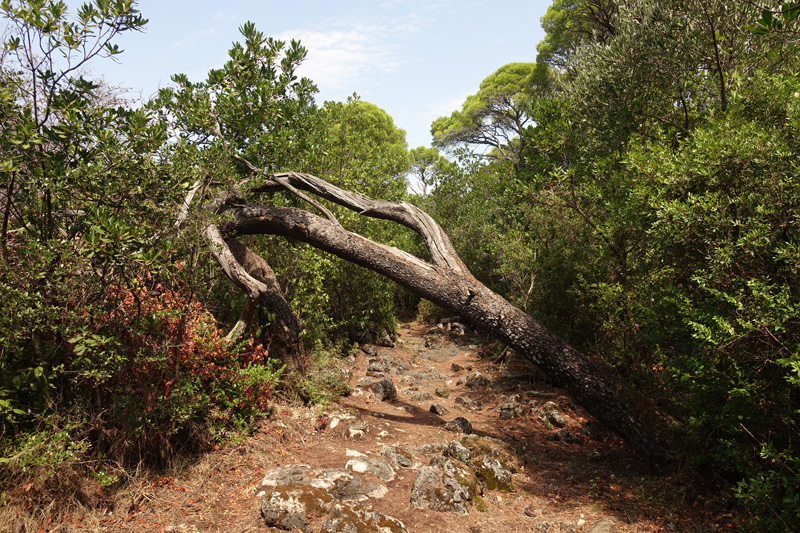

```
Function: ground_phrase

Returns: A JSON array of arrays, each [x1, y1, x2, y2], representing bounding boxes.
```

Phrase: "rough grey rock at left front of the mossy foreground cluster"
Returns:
[[411, 455, 478, 515]]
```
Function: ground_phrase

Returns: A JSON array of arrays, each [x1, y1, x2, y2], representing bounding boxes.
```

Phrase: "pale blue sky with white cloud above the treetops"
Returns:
[[75, 0, 550, 148]]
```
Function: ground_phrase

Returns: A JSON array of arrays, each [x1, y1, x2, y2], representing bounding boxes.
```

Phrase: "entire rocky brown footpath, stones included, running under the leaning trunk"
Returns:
[[108, 323, 730, 533]]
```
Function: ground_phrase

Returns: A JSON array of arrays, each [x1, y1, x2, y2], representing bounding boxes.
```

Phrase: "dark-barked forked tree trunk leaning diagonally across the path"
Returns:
[[220, 173, 665, 460]]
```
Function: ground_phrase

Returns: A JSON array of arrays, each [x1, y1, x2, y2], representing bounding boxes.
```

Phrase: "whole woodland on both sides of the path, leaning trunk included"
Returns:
[[0, 0, 800, 531]]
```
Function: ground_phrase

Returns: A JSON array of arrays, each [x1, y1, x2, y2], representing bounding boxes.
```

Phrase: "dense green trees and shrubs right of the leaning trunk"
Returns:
[[424, 0, 800, 530]]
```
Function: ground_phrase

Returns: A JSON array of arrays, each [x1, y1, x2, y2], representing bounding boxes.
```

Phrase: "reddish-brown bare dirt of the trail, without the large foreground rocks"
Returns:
[[90, 323, 731, 533]]
